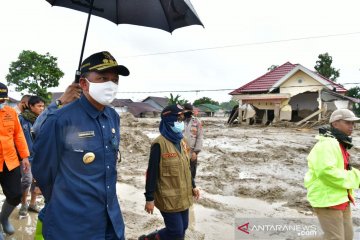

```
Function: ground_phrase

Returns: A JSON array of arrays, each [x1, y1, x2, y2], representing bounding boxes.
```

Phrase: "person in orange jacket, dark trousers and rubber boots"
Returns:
[[0, 83, 30, 240]]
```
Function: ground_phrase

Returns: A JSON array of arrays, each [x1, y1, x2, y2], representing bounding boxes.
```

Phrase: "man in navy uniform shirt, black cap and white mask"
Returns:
[[32, 52, 129, 240]]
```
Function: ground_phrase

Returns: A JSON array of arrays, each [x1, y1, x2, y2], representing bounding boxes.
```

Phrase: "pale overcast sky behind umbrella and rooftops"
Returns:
[[0, 0, 360, 102]]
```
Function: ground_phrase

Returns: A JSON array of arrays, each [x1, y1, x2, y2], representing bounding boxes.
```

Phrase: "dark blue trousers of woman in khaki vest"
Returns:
[[159, 209, 189, 240]]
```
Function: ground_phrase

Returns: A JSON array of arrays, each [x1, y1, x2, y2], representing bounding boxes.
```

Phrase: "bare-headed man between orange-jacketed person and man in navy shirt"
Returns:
[[19, 96, 45, 217]]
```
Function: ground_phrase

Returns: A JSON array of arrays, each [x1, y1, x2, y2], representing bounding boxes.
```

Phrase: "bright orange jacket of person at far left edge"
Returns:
[[0, 106, 30, 172]]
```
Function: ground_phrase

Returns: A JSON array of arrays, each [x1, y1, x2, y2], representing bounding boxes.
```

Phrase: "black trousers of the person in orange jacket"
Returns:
[[0, 163, 22, 206]]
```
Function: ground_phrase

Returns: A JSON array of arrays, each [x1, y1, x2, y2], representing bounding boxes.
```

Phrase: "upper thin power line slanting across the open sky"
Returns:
[[125, 32, 360, 58]]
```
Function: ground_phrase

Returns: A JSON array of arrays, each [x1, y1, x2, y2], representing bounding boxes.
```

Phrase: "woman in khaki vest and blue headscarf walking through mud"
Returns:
[[139, 105, 200, 240]]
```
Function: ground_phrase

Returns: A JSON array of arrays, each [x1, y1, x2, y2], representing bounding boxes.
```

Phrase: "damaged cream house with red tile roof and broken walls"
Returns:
[[230, 62, 358, 124]]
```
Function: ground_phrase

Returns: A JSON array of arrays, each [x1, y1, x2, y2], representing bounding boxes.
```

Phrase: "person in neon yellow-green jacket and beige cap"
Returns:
[[304, 109, 360, 240]]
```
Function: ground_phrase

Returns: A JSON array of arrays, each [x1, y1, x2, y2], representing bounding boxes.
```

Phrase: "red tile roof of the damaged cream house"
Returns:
[[229, 62, 347, 95]]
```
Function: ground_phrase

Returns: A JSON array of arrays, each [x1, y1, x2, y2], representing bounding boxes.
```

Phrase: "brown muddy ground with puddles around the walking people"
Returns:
[[7, 114, 360, 240]]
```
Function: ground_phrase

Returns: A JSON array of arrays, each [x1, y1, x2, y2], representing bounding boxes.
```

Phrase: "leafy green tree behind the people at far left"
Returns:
[[6, 50, 64, 102]]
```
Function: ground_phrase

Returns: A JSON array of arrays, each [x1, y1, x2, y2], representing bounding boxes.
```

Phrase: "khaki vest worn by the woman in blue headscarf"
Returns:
[[153, 135, 193, 212]]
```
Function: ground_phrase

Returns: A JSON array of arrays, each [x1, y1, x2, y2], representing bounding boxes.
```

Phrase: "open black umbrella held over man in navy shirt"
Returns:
[[46, 0, 203, 81]]
